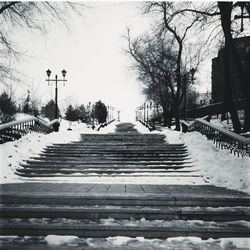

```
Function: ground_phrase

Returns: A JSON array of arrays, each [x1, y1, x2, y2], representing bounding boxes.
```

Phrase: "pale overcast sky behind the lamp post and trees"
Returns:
[[7, 2, 210, 121]]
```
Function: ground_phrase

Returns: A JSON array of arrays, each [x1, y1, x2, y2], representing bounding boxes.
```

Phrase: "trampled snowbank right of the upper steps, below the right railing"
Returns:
[[163, 129, 250, 194]]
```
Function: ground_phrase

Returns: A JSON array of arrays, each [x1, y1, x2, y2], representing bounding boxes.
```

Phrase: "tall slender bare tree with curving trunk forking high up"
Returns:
[[144, 2, 204, 130]]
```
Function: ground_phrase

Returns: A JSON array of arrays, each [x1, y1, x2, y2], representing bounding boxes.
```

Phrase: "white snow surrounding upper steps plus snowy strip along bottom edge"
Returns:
[[0, 121, 250, 249]]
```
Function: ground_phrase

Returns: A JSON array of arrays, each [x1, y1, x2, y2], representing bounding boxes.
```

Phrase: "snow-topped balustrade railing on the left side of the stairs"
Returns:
[[0, 117, 59, 144]]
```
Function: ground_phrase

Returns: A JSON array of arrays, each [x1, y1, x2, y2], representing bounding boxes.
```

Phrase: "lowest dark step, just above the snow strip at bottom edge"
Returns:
[[0, 218, 250, 239]]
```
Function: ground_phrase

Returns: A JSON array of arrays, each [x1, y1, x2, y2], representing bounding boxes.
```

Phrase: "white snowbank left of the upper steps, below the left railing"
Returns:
[[0, 119, 115, 183]]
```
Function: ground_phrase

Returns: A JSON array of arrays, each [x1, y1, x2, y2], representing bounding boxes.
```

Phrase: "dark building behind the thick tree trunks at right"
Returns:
[[212, 36, 250, 103]]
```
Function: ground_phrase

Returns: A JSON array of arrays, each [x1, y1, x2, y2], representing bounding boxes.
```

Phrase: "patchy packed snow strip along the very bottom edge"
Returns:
[[0, 235, 250, 250]]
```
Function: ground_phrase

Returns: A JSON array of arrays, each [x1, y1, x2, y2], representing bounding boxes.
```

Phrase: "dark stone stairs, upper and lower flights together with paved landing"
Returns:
[[0, 124, 250, 245]]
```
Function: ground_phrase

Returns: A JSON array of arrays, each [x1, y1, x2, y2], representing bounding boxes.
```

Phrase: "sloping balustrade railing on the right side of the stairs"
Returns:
[[181, 119, 250, 157]]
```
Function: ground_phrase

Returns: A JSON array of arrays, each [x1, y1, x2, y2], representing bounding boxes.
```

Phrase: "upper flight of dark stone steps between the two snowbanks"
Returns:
[[16, 132, 194, 177]]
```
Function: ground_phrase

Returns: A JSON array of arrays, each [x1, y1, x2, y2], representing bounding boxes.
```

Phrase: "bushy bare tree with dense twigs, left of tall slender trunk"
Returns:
[[127, 29, 200, 130]]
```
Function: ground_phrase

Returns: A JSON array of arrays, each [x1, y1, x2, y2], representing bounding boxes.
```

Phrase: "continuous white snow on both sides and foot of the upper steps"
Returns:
[[0, 120, 250, 193]]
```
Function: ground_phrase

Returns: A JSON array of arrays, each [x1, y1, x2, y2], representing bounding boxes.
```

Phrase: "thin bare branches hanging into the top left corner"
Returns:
[[0, 1, 85, 84]]
